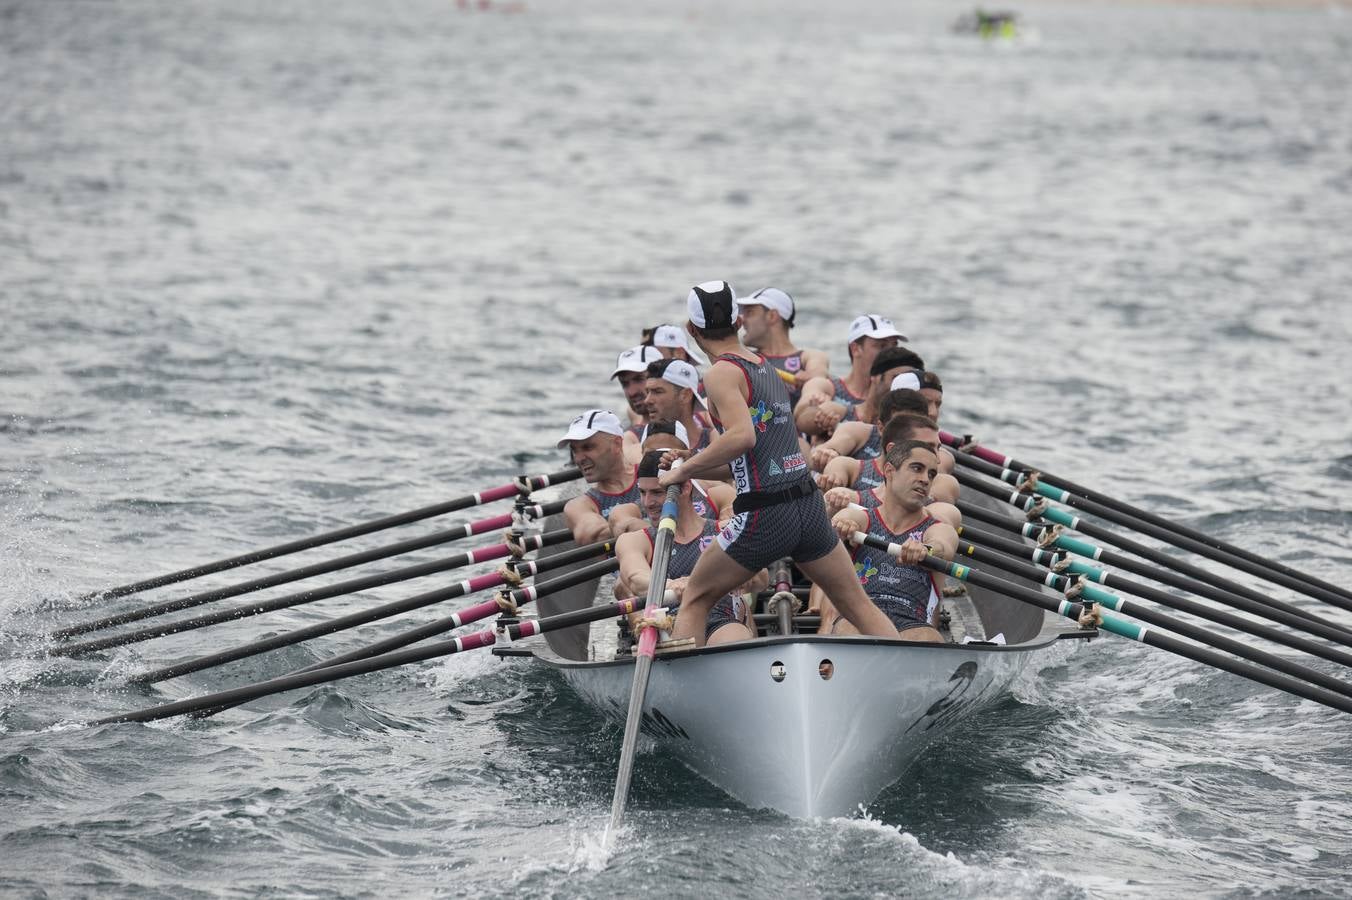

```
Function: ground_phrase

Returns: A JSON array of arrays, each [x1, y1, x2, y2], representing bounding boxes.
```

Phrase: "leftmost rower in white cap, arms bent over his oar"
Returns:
[[558, 409, 644, 545]]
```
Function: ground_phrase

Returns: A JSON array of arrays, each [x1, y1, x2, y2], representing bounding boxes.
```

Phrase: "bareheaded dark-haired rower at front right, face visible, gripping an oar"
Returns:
[[822, 441, 957, 643]]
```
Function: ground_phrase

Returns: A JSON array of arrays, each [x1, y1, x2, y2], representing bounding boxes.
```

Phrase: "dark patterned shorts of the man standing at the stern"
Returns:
[[718, 491, 840, 572]]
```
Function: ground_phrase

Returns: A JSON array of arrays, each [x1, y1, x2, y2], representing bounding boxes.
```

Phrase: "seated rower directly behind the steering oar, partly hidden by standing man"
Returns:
[[615, 450, 768, 645]]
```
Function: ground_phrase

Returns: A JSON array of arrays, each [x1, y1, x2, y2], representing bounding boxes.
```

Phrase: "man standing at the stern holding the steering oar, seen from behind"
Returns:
[[658, 281, 896, 645]]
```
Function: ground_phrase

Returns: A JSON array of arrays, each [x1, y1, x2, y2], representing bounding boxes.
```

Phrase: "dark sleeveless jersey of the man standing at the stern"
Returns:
[[718, 354, 807, 493]]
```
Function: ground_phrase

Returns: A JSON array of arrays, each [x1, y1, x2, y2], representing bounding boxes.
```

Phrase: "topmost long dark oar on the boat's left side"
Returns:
[[73, 469, 581, 604]]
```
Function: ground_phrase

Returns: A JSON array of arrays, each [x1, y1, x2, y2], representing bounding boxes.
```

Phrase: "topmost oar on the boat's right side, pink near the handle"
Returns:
[[940, 431, 1352, 609]]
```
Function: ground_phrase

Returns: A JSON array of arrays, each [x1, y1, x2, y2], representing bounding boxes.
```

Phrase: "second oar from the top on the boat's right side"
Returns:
[[956, 440, 1352, 609]]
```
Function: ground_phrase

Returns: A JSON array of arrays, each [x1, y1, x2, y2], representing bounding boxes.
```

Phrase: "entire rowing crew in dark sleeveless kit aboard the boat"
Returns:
[[558, 281, 959, 646]]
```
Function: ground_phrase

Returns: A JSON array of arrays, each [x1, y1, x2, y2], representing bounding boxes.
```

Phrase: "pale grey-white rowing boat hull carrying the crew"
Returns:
[[500, 486, 1094, 818]]
